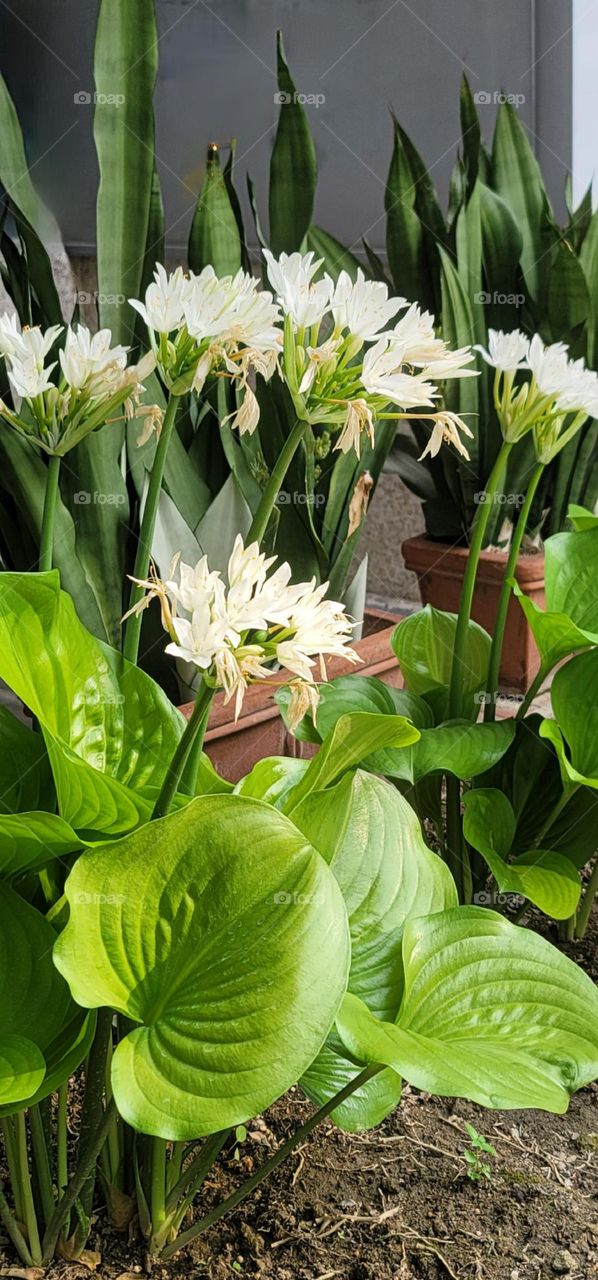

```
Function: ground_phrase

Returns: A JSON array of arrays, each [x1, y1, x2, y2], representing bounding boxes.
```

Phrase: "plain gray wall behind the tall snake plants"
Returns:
[[0, 0, 572, 252]]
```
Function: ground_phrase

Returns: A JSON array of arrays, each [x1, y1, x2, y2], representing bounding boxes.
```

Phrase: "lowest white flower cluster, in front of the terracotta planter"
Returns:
[[126, 535, 360, 719]]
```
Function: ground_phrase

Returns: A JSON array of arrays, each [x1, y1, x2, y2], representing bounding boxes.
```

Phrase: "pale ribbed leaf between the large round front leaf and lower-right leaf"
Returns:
[[293, 772, 457, 1133]]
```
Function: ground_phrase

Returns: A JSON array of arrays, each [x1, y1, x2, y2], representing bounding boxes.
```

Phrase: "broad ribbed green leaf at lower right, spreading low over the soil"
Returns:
[[337, 906, 598, 1114]]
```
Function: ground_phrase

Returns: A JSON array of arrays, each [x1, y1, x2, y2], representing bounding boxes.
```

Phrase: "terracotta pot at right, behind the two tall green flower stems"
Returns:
[[402, 538, 545, 692]]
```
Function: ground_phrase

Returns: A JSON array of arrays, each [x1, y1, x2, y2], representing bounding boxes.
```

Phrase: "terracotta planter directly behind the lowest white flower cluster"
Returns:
[[181, 609, 402, 782]]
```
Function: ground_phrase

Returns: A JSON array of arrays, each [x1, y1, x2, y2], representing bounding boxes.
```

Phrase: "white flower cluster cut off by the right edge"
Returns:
[[478, 329, 598, 462]]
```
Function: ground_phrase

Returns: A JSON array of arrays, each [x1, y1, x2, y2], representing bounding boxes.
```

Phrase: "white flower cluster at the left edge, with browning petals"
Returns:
[[0, 315, 159, 454]]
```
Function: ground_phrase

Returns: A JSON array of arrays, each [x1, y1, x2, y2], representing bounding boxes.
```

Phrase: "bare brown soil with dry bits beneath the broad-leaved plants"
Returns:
[[0, 918, 598, 1280]]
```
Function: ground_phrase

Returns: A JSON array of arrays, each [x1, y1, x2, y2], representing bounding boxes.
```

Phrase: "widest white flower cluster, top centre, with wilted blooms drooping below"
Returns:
[[131, 250, 475, 456]]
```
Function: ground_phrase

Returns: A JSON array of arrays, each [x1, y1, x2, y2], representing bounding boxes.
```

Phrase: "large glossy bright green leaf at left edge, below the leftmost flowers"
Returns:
[[0, 570, 184, 835]]
